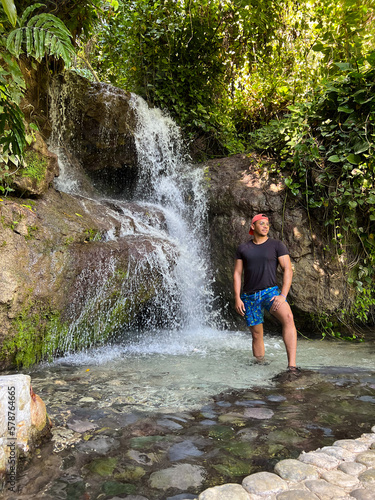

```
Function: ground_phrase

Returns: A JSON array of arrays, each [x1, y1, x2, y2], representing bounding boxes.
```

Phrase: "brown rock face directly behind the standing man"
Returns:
[[206, 155, 353, 332]]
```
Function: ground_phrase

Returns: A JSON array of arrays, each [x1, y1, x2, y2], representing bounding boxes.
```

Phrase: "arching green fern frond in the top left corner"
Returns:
[[6, 3, 74, 66]]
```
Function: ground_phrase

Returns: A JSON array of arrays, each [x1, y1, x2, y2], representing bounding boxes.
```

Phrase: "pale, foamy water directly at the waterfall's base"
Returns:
[[31, 329, 375, 412]]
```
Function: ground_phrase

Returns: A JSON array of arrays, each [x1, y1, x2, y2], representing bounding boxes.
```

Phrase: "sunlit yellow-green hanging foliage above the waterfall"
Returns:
[[76, 0, 374, 154]]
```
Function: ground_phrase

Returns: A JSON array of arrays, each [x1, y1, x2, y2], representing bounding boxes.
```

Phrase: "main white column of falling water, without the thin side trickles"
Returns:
[[131, 95, 216, 329]]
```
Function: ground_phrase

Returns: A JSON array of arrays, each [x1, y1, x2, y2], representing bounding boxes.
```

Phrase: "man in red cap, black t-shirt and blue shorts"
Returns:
[[233, 214, 299, 373]]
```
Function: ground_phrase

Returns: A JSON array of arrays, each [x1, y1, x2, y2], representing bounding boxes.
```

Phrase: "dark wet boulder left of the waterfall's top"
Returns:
[[48, 71, 138, 194]]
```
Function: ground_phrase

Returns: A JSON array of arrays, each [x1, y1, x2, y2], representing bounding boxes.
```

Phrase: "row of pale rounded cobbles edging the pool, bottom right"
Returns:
[[196, 426, 375, 500]]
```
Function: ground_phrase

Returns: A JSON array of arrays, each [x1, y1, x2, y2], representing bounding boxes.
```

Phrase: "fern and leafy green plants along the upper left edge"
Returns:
[[0, 0, 74, 192]]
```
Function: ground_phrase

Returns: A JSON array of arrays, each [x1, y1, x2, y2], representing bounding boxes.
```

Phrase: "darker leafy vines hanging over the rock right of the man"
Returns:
[[253, 61, 375, 332]]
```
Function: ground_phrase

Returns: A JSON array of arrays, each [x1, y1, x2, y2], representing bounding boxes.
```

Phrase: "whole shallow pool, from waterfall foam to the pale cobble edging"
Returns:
[[5, 329, 375, 500]]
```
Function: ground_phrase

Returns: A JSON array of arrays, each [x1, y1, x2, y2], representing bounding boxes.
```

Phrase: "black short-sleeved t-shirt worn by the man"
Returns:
[[236, 238, 289, 293]]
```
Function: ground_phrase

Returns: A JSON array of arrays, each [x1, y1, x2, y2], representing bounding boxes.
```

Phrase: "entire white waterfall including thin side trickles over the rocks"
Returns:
[[49, 77, 218, 352]]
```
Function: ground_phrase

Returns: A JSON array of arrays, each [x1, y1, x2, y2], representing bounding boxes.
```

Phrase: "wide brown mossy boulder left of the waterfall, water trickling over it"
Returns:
[[0, 189, 176, 368]]
